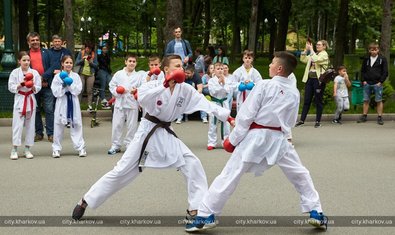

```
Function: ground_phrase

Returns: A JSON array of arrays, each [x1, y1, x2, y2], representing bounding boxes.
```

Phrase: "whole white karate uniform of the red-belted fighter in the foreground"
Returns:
[[198, 76, 322, 216]]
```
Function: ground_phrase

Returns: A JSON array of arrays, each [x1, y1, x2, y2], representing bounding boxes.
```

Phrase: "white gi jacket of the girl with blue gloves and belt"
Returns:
[[51, 71, 82, 126]]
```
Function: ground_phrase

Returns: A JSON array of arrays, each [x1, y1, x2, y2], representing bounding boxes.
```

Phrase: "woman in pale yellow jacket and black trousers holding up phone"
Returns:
[[296, 40, 329, 128]]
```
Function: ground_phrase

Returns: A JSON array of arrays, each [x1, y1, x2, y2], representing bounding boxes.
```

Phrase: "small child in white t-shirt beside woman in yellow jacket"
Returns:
[[332, 66, 351, 124]]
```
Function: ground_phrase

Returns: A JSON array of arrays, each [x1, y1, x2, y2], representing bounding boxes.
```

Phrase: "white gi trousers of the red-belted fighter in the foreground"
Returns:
[[198, 148, 322, 217]]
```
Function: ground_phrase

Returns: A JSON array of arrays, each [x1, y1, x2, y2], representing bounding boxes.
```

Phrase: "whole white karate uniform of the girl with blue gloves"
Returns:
[[51, 71, 85, 151]]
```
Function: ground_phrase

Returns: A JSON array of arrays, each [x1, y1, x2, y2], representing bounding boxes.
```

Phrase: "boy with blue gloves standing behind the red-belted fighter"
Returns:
[[233, 50, 262, 112]]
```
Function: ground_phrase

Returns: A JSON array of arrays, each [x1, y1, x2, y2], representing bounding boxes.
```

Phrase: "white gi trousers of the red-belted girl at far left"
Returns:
[[12, 109, 36, 146]]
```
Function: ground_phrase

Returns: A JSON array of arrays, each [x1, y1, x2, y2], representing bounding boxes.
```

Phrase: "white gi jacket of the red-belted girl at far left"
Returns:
[[8, 67, 41, 113]]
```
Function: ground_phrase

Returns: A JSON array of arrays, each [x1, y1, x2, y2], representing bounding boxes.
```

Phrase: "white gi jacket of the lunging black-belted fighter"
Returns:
[[136, 80, 230, 168]]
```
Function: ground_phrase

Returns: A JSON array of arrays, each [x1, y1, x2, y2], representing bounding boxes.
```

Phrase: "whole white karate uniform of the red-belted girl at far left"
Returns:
[[8, 67, 41, 146]]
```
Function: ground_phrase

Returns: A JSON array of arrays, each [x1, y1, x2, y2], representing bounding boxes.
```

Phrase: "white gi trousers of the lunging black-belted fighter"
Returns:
[[84, 139, 208, 210]]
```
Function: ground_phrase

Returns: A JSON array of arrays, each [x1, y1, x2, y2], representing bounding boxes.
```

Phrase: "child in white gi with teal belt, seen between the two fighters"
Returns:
[[207, 62, 231, 150]]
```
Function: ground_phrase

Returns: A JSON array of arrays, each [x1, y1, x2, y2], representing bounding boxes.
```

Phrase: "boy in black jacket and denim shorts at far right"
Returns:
[[358, 42, 388, 125]]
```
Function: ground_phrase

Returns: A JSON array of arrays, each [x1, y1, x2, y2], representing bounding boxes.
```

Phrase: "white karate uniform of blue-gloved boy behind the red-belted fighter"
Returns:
[[232, 65, 262, 112]]
